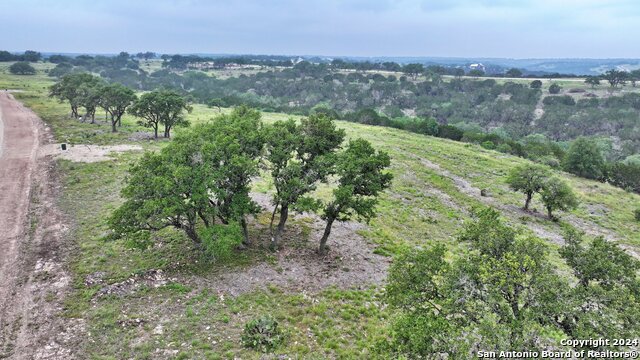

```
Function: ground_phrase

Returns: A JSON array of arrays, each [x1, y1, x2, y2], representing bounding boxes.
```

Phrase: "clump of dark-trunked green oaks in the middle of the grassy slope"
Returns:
[[109, 107, 392, 256]]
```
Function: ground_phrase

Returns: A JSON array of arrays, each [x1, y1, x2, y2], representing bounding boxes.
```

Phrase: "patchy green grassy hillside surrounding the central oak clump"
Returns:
[[5, 65, 640, 359]]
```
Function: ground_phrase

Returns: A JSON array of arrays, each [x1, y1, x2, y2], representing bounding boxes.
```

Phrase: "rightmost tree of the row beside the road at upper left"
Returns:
[[128, 90, 191, 139]]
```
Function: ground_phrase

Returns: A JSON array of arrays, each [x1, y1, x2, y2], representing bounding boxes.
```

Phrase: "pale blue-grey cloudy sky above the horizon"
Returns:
[[0, 0, 640, 58]]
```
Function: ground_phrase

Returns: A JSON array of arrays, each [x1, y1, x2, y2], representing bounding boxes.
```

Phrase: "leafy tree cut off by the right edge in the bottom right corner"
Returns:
[[558, 229, 640, 339]]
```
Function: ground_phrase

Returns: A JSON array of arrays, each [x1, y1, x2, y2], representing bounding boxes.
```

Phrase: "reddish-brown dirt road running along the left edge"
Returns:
[[0, 91, 73, 359]]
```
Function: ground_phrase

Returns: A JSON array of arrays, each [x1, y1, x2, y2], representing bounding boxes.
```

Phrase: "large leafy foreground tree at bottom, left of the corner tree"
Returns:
[[385, 209, 568, 359]]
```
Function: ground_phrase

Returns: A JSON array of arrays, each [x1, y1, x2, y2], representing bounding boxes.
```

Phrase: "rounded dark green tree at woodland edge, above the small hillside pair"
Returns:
[[562, 137, 605, 180]]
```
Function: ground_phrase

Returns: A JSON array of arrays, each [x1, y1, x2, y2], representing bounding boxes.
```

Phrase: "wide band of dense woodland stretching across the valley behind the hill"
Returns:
[[50, 56, 640, 157]]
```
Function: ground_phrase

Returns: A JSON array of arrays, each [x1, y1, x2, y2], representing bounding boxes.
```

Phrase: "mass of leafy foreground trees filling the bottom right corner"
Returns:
[[384, 209, 640, 358]]
